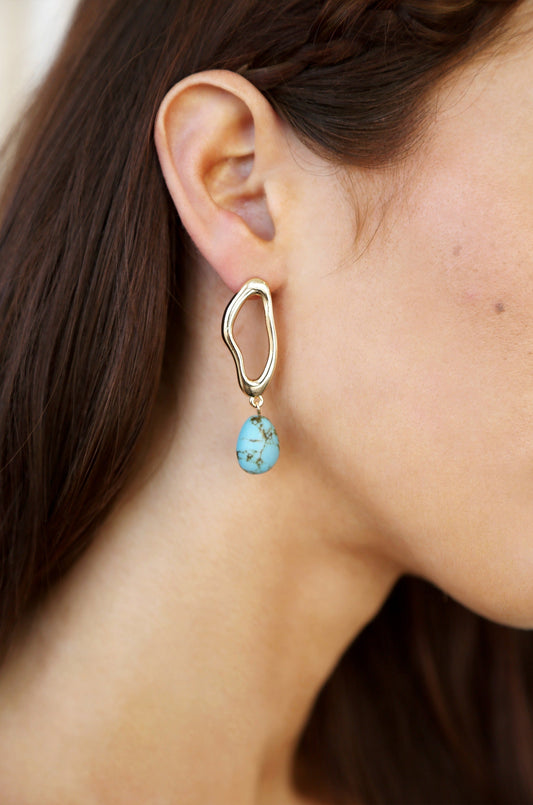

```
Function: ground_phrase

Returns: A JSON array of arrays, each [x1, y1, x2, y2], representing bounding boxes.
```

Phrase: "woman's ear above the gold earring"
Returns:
[[155, 70, 296, 292]]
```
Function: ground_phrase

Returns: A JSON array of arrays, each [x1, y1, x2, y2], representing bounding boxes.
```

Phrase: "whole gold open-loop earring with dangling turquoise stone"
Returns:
[[222, 278, 279, 475]]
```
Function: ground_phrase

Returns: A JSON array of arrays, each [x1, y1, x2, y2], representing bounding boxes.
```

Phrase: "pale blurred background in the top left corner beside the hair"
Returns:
[[0, 0, 77, 141]]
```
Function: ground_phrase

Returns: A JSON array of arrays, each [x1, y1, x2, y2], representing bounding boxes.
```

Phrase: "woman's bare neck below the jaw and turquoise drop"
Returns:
[[0, 322, 398, 805]]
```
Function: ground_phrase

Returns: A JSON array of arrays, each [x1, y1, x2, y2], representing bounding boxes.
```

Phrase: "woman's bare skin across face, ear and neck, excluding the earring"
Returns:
[[0, 1, 533, 805]]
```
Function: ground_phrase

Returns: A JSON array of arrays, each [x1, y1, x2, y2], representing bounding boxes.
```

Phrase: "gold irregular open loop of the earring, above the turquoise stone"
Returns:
[[222, 277, 278, 397]]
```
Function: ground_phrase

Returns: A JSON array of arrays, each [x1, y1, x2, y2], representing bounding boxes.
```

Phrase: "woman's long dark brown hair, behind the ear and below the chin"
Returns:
[[0, 0, 533, 803]]
